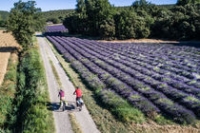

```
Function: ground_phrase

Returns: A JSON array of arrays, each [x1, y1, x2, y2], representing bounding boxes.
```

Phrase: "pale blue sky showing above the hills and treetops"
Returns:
[[0, 0, 177, 11]]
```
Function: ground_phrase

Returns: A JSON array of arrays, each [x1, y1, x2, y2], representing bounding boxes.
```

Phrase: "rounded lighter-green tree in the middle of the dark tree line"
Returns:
[[115, 10, 153, 39]]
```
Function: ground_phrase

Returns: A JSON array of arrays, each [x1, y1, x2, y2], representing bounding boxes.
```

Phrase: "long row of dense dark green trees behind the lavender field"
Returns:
[[63, 0, 200, 40]]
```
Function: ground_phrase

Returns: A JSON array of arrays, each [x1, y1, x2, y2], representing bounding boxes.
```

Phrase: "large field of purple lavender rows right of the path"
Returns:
[[47, 36, 200, 123]]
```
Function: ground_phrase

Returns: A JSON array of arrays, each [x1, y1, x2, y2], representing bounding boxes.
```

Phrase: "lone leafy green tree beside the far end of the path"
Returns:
[[7, 0, 45, 49]]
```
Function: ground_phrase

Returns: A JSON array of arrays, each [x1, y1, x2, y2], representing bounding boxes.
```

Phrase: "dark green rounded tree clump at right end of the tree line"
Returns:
[[151, 5, 200, 40]]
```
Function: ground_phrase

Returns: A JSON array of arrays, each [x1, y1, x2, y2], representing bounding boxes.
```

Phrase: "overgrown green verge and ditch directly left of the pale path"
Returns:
[[9, 47, 55, 133]]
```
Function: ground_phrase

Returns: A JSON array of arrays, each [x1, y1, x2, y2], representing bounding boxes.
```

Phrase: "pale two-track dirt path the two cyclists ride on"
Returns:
[[37, 33, 100, 133]]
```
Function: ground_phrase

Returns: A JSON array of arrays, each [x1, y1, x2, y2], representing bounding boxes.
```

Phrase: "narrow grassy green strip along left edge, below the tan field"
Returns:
[[0, 53, 18, 130]]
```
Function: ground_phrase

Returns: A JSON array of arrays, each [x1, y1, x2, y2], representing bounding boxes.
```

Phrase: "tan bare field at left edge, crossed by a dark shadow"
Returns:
[[0, 30, 20, 85]]
